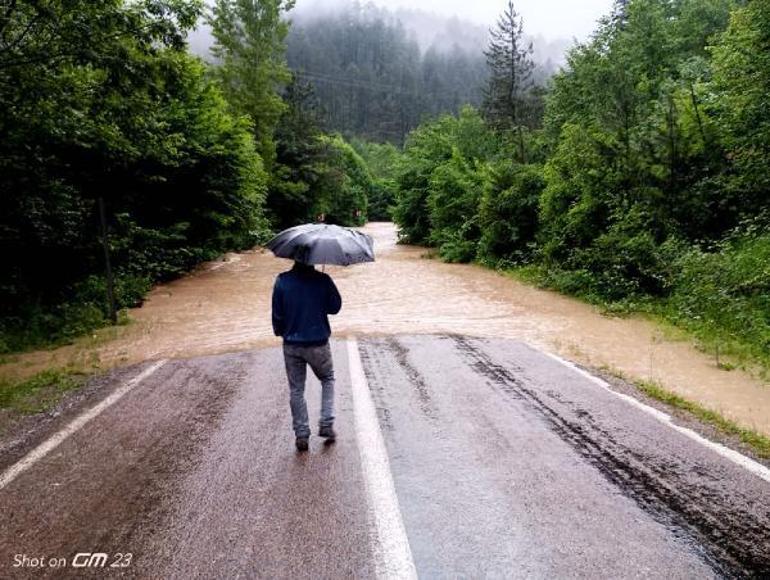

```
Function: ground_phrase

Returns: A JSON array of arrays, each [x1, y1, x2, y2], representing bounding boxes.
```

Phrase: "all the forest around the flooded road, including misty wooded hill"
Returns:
[[0, 0, 770, 372]]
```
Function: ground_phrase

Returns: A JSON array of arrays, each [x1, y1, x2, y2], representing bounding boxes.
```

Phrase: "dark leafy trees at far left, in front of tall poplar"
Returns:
[[0, 1, 266, 350]]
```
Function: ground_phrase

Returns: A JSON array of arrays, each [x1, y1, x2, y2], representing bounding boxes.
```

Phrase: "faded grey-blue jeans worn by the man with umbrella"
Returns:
[[283, 343, 334, 437]]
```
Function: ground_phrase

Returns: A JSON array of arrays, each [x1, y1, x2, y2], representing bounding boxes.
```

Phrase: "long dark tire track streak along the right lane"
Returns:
[[452, 336, 770, 577]]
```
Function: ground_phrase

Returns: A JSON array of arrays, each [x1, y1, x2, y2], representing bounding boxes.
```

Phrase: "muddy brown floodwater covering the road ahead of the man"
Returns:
[[0, 223, 770, 435]]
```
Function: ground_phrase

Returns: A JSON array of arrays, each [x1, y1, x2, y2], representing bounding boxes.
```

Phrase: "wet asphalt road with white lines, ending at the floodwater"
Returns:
[[0, 336, 770, 578]]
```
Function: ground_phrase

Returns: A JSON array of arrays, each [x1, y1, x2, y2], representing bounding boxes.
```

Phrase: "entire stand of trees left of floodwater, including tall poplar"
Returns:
[[0, 0, 373, 352]]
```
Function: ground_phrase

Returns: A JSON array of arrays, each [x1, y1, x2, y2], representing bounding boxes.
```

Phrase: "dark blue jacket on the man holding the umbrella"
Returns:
[[273, 263, 342, 346]]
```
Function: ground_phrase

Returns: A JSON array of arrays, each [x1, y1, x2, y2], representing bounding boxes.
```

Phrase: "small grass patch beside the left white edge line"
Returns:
[[0, 370, 86, 415]]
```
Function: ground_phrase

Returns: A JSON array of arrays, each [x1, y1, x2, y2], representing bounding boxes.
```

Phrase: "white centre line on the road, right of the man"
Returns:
[[348, 338, 417, 579]]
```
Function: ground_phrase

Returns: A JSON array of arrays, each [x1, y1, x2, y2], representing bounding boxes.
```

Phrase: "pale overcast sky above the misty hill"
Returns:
[[297, 0, 612, 40]]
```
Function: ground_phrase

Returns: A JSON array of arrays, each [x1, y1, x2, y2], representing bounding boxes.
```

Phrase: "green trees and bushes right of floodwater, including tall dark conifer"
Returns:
[[390, 0, 770, 370]]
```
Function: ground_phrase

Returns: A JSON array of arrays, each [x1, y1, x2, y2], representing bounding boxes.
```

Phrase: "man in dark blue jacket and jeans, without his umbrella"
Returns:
[[273, 262, 342, 451]]
